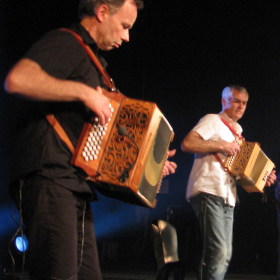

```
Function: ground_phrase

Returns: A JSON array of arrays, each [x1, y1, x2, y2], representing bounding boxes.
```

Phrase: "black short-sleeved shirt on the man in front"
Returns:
[[11, 23, 106, 193]]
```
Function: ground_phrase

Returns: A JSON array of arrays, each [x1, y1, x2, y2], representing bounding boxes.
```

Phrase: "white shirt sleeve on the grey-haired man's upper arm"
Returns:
[[192, 114, 220, 140]]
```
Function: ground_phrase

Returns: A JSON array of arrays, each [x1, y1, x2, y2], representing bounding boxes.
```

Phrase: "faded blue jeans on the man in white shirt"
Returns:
[[190, 193, 234, 280]]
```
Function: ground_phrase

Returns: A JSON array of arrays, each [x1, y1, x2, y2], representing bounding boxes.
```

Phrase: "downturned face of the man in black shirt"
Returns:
[[96, 0, 137, 51]]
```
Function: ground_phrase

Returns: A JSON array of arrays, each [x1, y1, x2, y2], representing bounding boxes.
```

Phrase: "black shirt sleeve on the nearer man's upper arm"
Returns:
[[24, 29, 85, 79]]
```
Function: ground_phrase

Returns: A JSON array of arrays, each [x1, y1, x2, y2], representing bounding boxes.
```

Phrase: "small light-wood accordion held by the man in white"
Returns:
[[225, 141, 275, 192]]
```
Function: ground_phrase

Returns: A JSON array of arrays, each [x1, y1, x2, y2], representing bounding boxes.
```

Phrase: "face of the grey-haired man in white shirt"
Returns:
[[222, 89, 248, 121]]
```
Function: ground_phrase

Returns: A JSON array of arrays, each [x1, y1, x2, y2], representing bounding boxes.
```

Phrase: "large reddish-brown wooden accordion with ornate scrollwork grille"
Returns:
[[71, 89, 174, 208]]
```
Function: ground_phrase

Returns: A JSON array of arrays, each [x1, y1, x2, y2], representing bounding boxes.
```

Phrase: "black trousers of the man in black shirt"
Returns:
[[15, 176, 102, 280]]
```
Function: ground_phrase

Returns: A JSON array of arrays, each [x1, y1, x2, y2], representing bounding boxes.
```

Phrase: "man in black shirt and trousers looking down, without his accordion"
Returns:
[[5, 0, 176, 280]]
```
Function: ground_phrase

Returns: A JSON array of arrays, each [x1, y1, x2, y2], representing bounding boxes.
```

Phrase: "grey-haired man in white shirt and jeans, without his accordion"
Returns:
[[181, 85, 276, 280]]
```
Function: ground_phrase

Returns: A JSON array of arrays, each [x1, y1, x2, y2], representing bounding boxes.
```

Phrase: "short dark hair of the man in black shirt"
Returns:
[[78, 0, 144, 19]]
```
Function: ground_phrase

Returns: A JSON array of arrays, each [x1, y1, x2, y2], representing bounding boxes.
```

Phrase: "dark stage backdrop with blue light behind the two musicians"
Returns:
[[0, 0, 280, 274]]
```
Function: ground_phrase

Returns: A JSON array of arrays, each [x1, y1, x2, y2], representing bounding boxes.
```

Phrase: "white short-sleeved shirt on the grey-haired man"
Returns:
[[187, 114, 242, 206]]
